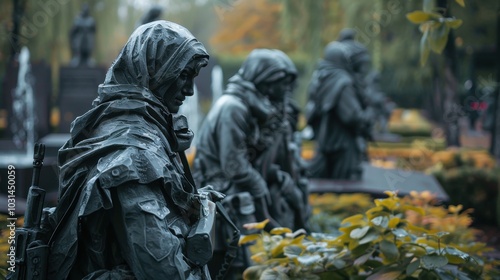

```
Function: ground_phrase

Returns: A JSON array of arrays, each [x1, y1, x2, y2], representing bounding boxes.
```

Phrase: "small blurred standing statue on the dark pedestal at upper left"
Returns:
[[69, 4, 96, 67]]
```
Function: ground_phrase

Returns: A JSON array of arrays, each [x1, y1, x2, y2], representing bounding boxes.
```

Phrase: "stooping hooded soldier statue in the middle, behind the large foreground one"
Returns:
[[193, 49, 296, 276]]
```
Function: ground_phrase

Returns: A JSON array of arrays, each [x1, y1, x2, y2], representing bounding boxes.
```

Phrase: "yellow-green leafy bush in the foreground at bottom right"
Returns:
[[241, 192, 499, 280]]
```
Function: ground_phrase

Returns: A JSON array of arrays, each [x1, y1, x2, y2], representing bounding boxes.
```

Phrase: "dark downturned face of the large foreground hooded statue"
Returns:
[[160, 59, 201, 113]]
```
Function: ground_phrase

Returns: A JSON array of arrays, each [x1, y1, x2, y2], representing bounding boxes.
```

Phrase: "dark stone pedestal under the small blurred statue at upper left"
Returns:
[[57, 66, 106, 133]]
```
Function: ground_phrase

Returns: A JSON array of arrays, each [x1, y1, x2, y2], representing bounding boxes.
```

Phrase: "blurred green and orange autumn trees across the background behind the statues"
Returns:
[[0, 0, 499, 155]]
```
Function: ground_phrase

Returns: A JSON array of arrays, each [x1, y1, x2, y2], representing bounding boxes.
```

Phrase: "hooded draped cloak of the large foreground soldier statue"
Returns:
[[49, 21, 208, 279]]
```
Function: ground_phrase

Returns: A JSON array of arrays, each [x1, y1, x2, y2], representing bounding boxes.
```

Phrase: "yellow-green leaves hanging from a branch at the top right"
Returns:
[[406, 0, 465, 66]]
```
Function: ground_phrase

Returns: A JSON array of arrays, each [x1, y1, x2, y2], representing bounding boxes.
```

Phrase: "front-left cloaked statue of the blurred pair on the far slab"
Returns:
[[306, 41, 373, 180]]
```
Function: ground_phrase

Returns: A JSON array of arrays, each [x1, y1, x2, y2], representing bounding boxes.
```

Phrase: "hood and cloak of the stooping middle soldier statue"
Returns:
[[194, 49, 295, 197]]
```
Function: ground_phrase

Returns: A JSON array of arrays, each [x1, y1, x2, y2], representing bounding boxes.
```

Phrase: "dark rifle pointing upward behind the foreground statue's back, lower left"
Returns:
[[7, 143, 49, 280]]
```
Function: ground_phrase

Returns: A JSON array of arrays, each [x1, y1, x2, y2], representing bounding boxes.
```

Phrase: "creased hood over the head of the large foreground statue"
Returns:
[[96, 20, 209, 103]]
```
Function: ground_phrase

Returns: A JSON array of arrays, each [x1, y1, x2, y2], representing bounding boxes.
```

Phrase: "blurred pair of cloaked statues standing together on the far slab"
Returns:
[[306, 29, 391, 180]]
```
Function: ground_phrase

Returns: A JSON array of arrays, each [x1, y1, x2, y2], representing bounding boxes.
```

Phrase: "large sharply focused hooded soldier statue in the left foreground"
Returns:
[[44, 21, 211, 279]]
